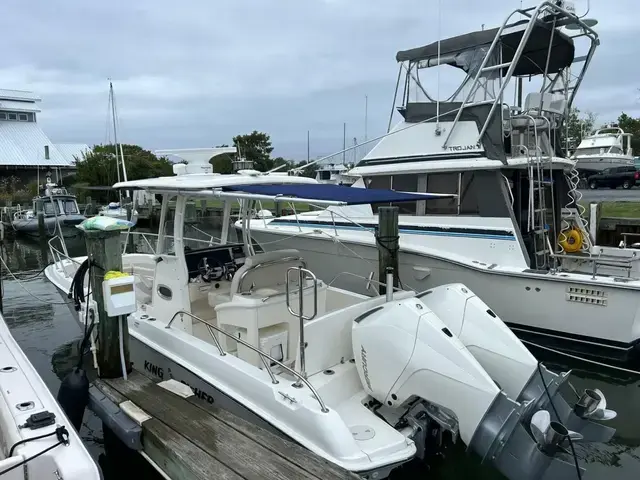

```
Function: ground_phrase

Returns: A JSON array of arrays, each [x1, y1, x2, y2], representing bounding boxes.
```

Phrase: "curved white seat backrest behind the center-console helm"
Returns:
[[229, 249, 305, 297]]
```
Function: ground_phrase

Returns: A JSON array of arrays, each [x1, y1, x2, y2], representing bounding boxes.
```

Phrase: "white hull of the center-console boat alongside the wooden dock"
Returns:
[[45, 257, 416, 479]]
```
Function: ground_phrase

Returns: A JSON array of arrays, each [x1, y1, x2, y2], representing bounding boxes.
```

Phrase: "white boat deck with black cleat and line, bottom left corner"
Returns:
[[0, 310, 101, 480]]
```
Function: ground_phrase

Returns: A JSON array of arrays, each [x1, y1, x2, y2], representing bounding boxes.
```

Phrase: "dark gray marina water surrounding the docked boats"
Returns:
[[3, 234, 640, 480]]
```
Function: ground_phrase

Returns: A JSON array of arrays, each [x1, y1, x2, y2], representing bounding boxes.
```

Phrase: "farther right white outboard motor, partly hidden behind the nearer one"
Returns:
[[417, 283, 616, 442]]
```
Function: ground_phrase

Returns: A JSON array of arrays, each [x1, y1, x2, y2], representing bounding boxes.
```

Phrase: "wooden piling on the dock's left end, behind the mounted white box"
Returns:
[[84, 230, 131, 378]]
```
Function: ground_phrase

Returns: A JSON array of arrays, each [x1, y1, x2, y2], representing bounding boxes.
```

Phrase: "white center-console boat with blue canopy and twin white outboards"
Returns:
[[45, 157, 615, 480]]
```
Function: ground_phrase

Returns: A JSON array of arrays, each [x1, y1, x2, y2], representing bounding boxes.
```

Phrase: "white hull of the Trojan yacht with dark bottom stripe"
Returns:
[[251, 225, 640, 362]]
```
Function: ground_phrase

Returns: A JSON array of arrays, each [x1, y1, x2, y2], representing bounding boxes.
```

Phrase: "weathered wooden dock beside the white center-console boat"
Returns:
[[94, 371, 360, 480]]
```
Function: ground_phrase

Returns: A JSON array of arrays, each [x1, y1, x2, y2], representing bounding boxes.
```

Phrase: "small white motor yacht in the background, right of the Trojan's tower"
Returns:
[[571, 127, 635, 176]]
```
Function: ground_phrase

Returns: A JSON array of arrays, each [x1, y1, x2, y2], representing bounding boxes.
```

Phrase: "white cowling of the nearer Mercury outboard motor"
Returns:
[[352, 298, 500, 445]]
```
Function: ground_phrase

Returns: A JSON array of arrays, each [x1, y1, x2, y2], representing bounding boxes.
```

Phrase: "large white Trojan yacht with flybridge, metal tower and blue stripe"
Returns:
[[241, 2, 640, 361]]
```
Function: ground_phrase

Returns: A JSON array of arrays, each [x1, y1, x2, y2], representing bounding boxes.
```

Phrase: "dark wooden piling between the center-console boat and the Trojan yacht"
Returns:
[[376, 207, 400, 294]]
